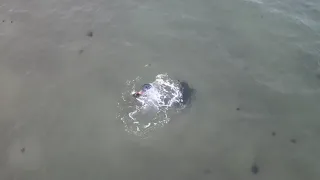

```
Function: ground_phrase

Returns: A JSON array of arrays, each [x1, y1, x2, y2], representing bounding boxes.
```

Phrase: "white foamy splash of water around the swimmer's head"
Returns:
[[117, 74, 185, 136]]
